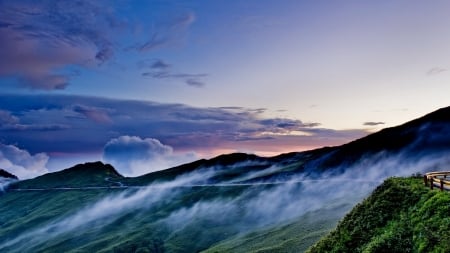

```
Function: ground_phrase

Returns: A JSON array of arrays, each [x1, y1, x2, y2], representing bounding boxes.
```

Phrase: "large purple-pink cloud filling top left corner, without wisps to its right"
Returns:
[[0, 1, 115, 90]]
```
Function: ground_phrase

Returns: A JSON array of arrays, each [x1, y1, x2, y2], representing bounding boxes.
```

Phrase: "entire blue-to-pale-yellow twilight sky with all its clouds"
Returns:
[[0, 0, 450, 178]]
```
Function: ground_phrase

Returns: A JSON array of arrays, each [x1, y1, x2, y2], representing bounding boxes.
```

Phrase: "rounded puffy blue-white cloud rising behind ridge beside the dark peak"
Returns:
[[103, 136, 196, 176]]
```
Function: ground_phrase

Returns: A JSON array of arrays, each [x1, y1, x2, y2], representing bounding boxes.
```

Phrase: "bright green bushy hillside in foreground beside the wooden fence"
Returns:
[[308, 178, 450, 253]]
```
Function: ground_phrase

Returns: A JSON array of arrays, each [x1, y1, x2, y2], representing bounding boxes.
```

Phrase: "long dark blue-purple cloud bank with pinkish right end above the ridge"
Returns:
[[0, 95, 366, 153]]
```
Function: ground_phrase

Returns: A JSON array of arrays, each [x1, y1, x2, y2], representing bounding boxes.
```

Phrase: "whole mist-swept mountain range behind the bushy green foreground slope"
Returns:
[[0, 107, 450, 252]]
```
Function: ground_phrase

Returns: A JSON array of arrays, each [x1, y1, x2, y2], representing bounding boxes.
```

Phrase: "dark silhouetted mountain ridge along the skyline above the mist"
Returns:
[[7, 106, 450, 188]]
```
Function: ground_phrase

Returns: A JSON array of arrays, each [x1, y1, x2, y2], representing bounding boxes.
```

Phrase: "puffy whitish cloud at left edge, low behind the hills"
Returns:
[[0, 143, 49, 179]]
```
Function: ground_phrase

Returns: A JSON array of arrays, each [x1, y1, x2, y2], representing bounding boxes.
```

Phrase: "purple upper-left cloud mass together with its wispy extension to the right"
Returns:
[[0, 0, 197, 91]]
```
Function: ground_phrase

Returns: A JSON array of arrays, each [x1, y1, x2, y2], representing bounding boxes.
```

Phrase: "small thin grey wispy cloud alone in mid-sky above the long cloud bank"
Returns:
[[138, 59, 208, 87]]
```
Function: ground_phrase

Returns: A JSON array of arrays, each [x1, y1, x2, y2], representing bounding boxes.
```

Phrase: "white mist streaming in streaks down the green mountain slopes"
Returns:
[[0, 146, 450, 252]]
